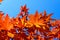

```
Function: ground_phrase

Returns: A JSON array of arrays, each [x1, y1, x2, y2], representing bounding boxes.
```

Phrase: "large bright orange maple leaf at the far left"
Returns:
[[3, 14, 13, 30]]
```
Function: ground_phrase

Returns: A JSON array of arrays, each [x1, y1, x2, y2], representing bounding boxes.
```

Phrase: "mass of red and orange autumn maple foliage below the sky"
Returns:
[[0, 5, 60, 40]]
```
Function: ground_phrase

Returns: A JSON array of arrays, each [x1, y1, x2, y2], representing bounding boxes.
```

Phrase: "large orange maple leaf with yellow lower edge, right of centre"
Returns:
[[29, 11, 45, 27]]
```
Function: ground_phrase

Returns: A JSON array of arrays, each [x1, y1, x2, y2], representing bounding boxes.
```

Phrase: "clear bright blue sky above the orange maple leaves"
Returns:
[[0, 0, 60, 19]]
